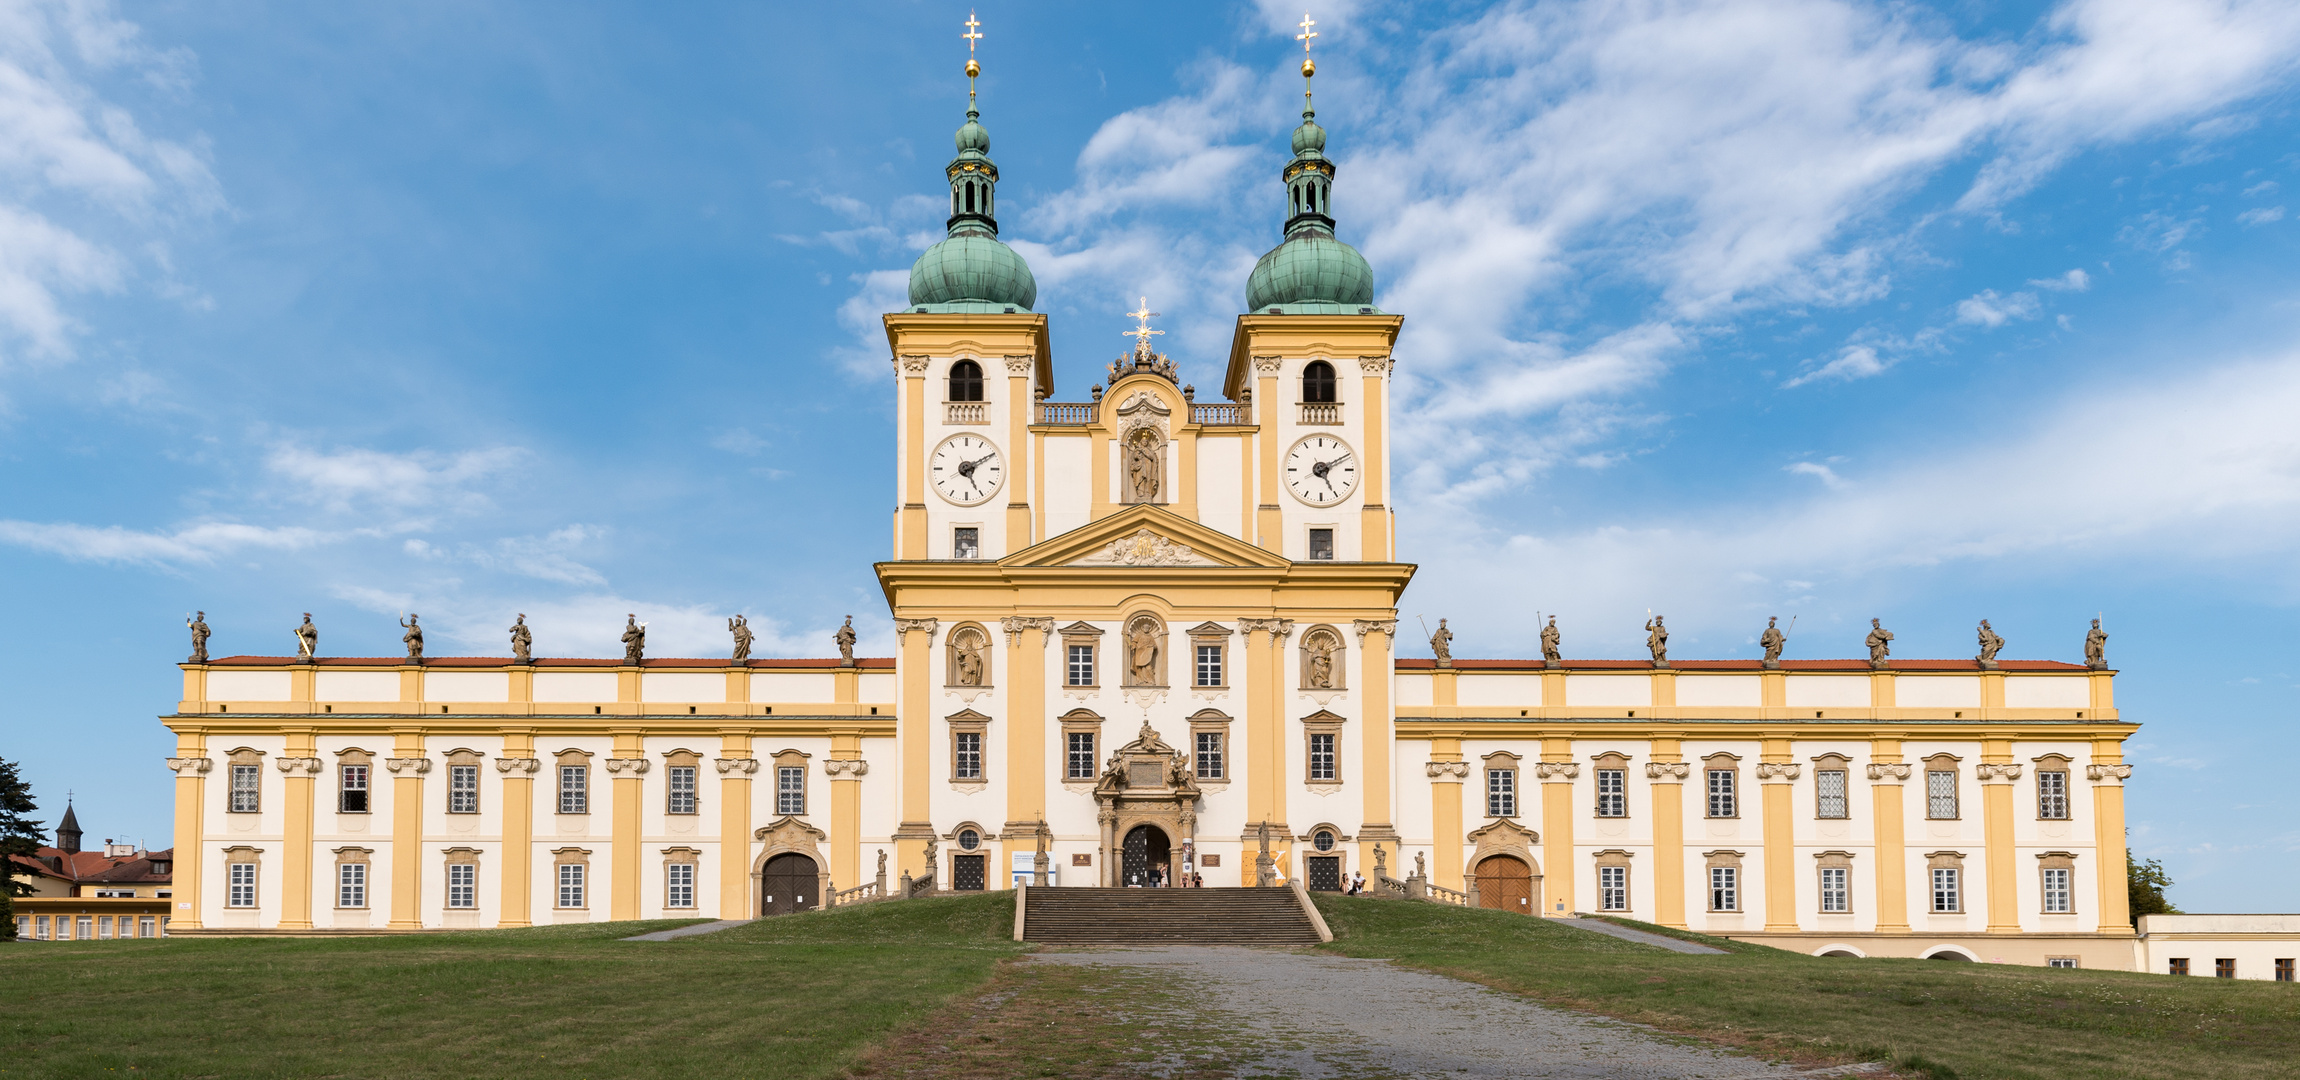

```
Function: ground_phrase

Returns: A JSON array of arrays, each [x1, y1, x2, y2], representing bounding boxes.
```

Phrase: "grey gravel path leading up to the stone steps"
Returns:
[[1028, 947, 1858, 1080]]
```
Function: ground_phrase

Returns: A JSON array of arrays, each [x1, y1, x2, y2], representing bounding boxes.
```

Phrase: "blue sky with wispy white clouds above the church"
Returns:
[[0, 0, 2300, 910]]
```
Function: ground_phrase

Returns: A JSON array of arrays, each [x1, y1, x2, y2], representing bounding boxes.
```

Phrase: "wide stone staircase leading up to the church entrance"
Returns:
[[1021, 887, 1318, 944]]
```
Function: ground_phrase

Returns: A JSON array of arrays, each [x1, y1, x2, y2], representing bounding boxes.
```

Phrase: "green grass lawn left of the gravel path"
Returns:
[[0, 894, 1024, 1080]]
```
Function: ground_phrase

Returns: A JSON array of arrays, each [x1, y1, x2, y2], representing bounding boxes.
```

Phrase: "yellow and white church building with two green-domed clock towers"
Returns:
[[161, 48, 2134, 967]]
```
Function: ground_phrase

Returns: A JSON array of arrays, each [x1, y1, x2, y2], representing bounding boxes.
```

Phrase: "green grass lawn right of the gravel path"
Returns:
[[1318, 896, 2300, 1080]]
